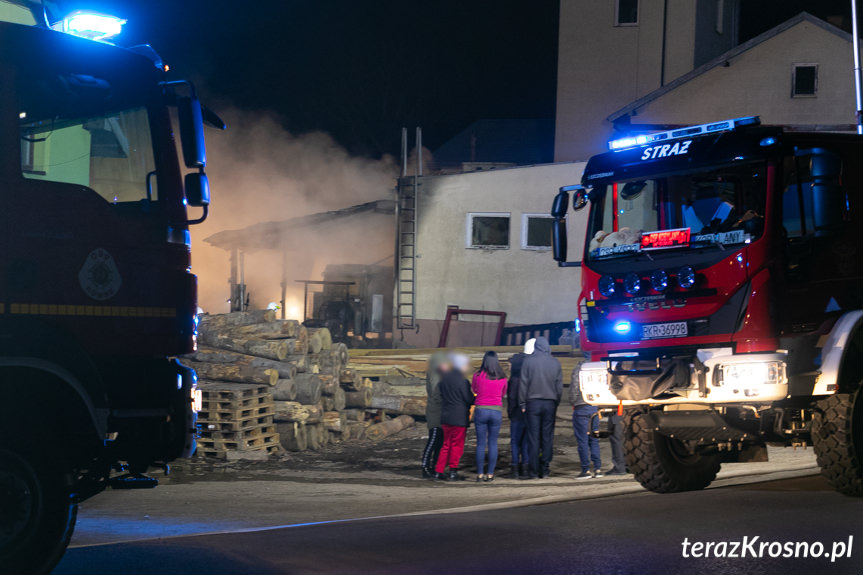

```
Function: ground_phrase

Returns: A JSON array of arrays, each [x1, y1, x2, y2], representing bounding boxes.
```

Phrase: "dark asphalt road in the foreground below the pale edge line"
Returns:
[[55, 476, 863, 575]]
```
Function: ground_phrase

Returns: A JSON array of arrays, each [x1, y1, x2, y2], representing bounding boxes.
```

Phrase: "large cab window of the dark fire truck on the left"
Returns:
[[18, 71, 157, 204]]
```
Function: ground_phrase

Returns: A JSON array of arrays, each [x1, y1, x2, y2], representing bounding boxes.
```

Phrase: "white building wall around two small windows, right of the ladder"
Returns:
[[404, 163, 587, 347]]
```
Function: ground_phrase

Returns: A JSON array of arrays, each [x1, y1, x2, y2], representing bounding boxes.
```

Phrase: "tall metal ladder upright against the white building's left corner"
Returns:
[[395, 128, 422, 329]]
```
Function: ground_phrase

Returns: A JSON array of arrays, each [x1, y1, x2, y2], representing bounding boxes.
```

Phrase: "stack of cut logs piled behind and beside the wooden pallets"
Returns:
[[181, 310, 425, 451]]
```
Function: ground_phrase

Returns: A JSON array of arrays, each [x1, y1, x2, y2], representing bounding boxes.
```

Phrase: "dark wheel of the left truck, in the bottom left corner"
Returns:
[[0, 449, 78, 575]]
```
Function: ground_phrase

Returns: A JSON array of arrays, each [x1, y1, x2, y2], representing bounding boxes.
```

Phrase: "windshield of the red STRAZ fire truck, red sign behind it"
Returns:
[[588, 163, 766, 261]]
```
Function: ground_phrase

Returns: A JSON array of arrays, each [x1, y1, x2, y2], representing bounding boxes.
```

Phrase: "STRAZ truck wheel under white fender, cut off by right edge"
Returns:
[[812, 394, 863, 497]]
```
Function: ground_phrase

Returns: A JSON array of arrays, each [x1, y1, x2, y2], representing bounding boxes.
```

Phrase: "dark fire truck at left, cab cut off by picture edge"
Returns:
[[0, 1, 223, 574]]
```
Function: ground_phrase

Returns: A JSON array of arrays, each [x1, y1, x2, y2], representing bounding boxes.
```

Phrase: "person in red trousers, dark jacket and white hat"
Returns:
[[435, 354, 474, 481]]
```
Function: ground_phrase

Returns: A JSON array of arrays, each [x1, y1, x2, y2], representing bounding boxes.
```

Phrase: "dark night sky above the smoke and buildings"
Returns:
[[45, 0, 863, 157]]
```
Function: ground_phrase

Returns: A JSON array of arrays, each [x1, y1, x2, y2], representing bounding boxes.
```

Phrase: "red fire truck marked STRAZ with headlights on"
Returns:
[[552, 117, 863, 496]]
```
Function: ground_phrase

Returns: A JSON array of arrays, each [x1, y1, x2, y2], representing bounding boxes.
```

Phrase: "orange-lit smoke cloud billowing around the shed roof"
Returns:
[[190, 110, 398, 319]]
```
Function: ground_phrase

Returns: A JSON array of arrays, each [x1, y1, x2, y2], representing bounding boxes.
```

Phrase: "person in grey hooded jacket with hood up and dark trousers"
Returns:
[[518, 337, 563, 479]]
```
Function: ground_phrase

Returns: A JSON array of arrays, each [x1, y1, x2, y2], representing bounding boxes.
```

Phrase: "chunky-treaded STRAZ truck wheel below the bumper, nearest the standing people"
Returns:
[[624, 413, 721, 493]]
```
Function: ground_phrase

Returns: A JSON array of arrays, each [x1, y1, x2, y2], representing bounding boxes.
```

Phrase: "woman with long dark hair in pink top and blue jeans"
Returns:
[[472, 351, 506, 482]]
